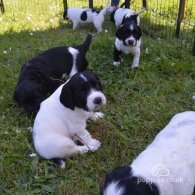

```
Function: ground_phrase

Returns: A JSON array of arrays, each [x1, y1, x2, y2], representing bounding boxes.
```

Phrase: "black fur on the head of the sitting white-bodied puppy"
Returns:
[[60, 71, 102, 111]]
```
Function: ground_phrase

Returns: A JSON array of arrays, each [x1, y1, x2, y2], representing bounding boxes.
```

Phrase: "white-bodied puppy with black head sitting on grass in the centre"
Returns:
[[33, 71, 106, 166]]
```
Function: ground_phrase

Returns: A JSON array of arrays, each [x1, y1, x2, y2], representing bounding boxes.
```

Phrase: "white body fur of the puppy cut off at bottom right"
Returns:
[[131, 111, 195, 195]]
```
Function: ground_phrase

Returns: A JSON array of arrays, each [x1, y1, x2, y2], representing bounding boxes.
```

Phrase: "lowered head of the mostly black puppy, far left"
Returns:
[[13, 80, 46, 116]]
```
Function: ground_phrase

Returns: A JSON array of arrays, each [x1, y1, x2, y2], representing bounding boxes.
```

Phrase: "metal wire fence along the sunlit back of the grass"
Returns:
[[0, 0, 195, 55]]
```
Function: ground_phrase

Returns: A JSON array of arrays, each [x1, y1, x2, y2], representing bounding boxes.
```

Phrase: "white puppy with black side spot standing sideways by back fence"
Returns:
[[64, 0, 110, 32]]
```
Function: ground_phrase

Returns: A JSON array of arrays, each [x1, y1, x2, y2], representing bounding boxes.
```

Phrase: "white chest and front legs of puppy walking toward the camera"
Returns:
[[113, 38, 141, 68]]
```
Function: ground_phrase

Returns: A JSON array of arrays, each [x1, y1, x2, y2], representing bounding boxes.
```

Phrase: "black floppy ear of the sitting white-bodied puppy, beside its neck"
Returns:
[[60, 82, 75, 110]]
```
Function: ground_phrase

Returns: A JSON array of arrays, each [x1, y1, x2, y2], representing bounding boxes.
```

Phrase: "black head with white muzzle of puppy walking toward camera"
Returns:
[[116, 15, 142, 47]]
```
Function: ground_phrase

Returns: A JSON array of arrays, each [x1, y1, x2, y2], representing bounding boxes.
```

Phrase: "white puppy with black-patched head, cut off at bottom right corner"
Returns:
[[102, 111, 195, 195]]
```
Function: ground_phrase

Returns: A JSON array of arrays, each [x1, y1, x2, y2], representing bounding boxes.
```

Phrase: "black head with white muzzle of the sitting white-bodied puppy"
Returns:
[[60, 71, 106, 112]]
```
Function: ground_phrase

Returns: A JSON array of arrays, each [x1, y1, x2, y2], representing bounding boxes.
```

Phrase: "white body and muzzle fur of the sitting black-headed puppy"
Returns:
[[33, 81, 106, 159]]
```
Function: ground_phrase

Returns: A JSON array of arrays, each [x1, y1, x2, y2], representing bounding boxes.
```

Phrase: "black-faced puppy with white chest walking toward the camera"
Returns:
[[113, 8, 143, 68]]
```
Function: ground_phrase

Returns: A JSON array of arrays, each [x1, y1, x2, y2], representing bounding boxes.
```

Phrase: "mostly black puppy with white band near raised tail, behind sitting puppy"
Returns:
[[13, 34, 92, 115]]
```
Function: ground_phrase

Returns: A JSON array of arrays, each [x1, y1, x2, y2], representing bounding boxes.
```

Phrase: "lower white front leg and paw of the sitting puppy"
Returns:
[[76, 129, 101, 152]]
